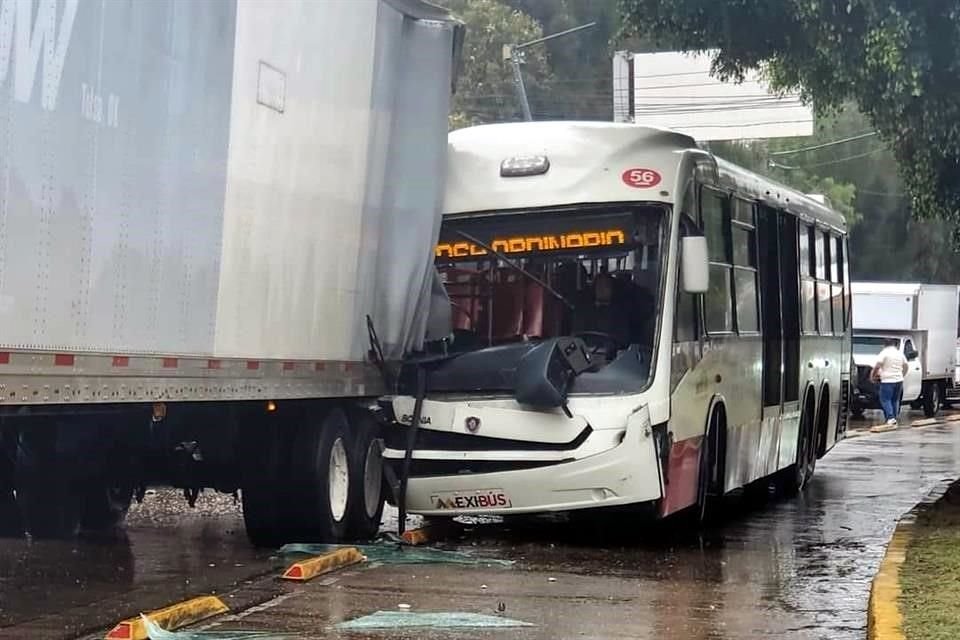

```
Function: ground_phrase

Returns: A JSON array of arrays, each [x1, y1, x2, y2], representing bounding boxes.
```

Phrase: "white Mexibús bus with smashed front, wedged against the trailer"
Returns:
[[381, 122, 850, 516]]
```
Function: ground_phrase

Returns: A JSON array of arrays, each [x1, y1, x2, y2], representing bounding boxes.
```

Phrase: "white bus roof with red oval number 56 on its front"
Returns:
[[444, 121, 846, 229]]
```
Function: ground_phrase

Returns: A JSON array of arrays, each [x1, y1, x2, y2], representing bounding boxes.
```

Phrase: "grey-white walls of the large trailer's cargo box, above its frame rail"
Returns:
[[0, 0, 456, 361]]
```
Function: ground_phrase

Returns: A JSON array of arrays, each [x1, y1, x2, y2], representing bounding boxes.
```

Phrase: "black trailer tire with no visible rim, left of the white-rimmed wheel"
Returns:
[[238, 418, 290, 548]]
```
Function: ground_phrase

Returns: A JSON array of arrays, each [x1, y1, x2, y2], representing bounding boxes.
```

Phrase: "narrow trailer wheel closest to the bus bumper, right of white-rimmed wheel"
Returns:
[[350, 415, 386, 540]]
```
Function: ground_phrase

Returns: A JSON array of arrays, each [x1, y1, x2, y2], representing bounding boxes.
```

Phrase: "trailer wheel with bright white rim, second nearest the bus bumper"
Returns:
[[293, 408, 356, 542]]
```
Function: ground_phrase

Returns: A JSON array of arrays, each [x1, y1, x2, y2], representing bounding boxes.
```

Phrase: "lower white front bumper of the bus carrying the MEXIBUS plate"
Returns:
[[385, 409, 663, 516]]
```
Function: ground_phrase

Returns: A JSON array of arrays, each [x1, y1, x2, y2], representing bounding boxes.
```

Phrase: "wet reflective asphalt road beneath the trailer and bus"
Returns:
[[0, 412, 960, 640]]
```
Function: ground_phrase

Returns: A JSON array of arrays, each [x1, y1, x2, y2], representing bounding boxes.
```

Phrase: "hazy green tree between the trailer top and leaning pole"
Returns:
[[441, 0, 551, 129]]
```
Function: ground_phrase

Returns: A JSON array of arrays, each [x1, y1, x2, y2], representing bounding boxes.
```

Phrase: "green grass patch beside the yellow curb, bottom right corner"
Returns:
[[900, 483, 960, 640]]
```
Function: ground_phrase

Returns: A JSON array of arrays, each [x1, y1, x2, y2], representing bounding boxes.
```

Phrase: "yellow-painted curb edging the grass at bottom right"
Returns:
[[867, 480, 955, 640]]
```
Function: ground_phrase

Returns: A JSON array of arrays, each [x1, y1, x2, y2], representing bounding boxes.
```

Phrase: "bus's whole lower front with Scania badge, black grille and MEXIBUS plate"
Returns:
[[384, 403, 662, 516]]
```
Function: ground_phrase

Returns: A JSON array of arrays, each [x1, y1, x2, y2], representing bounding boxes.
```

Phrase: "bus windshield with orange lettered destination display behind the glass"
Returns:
[[436, 206, 666, 366]]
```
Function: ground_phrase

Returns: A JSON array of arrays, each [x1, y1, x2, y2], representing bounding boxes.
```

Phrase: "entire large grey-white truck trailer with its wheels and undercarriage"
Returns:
[[0, 0, 462, 544]]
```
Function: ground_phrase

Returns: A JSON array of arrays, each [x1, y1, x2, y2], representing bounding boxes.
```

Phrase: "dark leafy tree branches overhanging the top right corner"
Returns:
[[620, 0, 960, 226]]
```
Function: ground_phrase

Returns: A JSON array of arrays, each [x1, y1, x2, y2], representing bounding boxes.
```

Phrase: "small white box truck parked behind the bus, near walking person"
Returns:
[[852, 282, 960, 417]]
